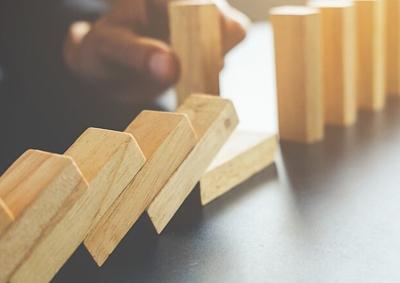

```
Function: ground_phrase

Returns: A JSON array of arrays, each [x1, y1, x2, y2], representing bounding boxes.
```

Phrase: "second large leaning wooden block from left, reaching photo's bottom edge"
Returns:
[[11, 128, 145, 282]]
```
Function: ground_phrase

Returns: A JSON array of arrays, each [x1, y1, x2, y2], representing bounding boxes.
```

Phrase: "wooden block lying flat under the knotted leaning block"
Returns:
[[200, 130, 277, 205]]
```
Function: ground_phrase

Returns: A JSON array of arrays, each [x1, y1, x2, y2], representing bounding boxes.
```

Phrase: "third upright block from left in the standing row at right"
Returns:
[[354, 0, 386, 111]]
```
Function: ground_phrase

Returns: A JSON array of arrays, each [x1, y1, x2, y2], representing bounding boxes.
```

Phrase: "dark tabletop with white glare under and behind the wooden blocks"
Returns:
[[55, 24, 400, 283]]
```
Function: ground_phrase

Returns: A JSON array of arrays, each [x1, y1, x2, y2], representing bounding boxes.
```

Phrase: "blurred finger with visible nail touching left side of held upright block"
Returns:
[[95, 23, 179, 85]]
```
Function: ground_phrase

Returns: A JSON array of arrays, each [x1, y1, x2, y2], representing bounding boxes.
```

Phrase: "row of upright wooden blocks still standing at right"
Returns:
[[270, 0, 400, 143]]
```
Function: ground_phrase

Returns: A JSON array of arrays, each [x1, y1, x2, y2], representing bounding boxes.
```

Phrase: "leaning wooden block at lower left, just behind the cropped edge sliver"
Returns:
[[0, 150, 87, 282]]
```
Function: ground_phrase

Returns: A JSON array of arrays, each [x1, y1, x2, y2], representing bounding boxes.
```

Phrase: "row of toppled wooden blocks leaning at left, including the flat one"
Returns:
[[0, 95, 276, 282]]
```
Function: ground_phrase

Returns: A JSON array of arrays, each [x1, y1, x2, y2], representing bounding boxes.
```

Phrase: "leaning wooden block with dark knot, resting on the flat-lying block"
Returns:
[[147, 95, 238, 233]]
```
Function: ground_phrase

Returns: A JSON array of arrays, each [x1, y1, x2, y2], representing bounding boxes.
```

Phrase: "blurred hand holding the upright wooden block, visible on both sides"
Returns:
[[64, 0, 248, 102]]
